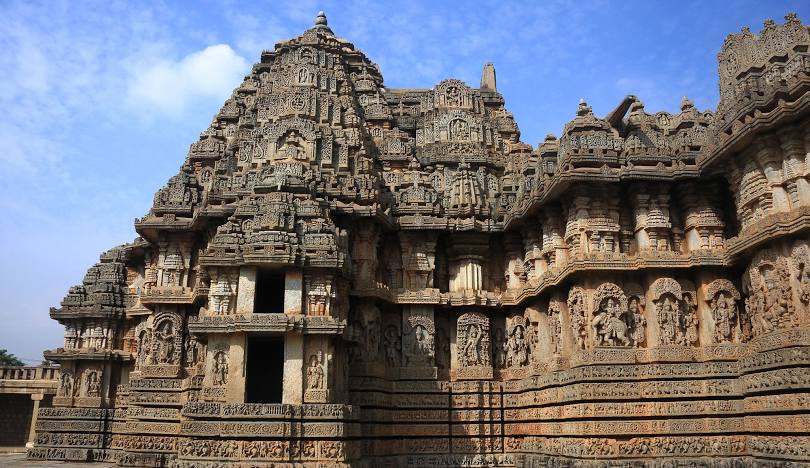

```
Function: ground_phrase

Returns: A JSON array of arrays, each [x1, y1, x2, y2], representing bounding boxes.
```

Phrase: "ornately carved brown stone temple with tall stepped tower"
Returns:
[[28, 10, 810, 468]]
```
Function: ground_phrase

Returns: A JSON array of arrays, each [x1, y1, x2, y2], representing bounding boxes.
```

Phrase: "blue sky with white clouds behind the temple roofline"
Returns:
[[0, 0, 810, 362]]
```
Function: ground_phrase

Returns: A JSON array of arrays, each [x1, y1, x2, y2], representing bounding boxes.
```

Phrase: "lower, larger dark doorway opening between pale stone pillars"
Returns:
[[245, 337, 284, 403]]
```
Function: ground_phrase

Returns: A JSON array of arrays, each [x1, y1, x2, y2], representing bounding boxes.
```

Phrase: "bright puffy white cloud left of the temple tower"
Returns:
[[128, 44, 249, 115]]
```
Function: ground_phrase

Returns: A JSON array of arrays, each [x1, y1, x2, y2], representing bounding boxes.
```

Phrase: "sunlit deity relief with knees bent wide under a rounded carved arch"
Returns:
[[591, 283, 630, 346]]
